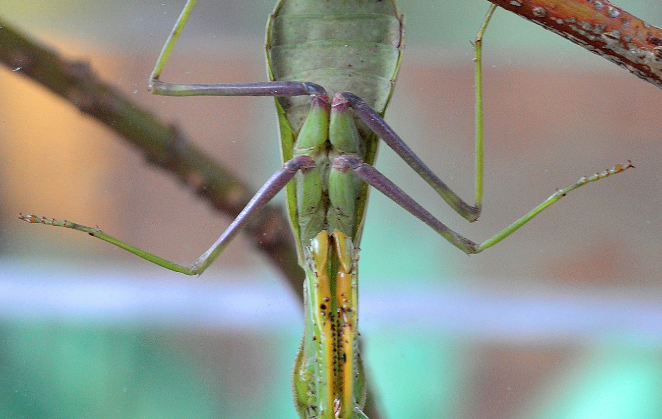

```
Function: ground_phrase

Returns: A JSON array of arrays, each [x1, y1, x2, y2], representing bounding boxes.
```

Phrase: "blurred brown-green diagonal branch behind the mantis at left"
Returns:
[[0, 18, 303, 299]]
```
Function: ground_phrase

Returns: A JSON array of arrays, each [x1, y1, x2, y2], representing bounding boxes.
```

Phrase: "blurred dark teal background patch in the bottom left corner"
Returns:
[[0, 322, 220, 419]]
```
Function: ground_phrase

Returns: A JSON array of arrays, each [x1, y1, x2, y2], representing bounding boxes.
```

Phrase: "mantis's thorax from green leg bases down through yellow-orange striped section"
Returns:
[[292, 87, 366, 419]]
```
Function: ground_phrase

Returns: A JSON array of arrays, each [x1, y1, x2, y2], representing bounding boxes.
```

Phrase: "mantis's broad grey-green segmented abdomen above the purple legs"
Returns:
[[267, 0, 403, 131]]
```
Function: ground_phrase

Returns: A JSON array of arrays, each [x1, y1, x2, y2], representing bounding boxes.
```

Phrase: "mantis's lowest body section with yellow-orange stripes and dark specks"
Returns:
[[293, 230, 366, 419]]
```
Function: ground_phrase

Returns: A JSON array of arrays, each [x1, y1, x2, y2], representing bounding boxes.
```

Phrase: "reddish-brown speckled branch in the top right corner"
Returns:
[[488, 0, 662, 88]]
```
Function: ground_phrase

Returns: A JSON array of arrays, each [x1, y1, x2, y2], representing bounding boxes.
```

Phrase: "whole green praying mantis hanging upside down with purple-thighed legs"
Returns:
[[21, 0, 632, 419]]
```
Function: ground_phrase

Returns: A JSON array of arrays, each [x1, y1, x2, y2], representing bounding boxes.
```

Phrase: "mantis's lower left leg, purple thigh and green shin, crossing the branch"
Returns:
[[19, 155, 315, 275]]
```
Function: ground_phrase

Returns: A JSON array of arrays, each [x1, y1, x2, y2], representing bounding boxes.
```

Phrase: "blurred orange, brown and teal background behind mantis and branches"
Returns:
[[0, 0, 662, 419]]
